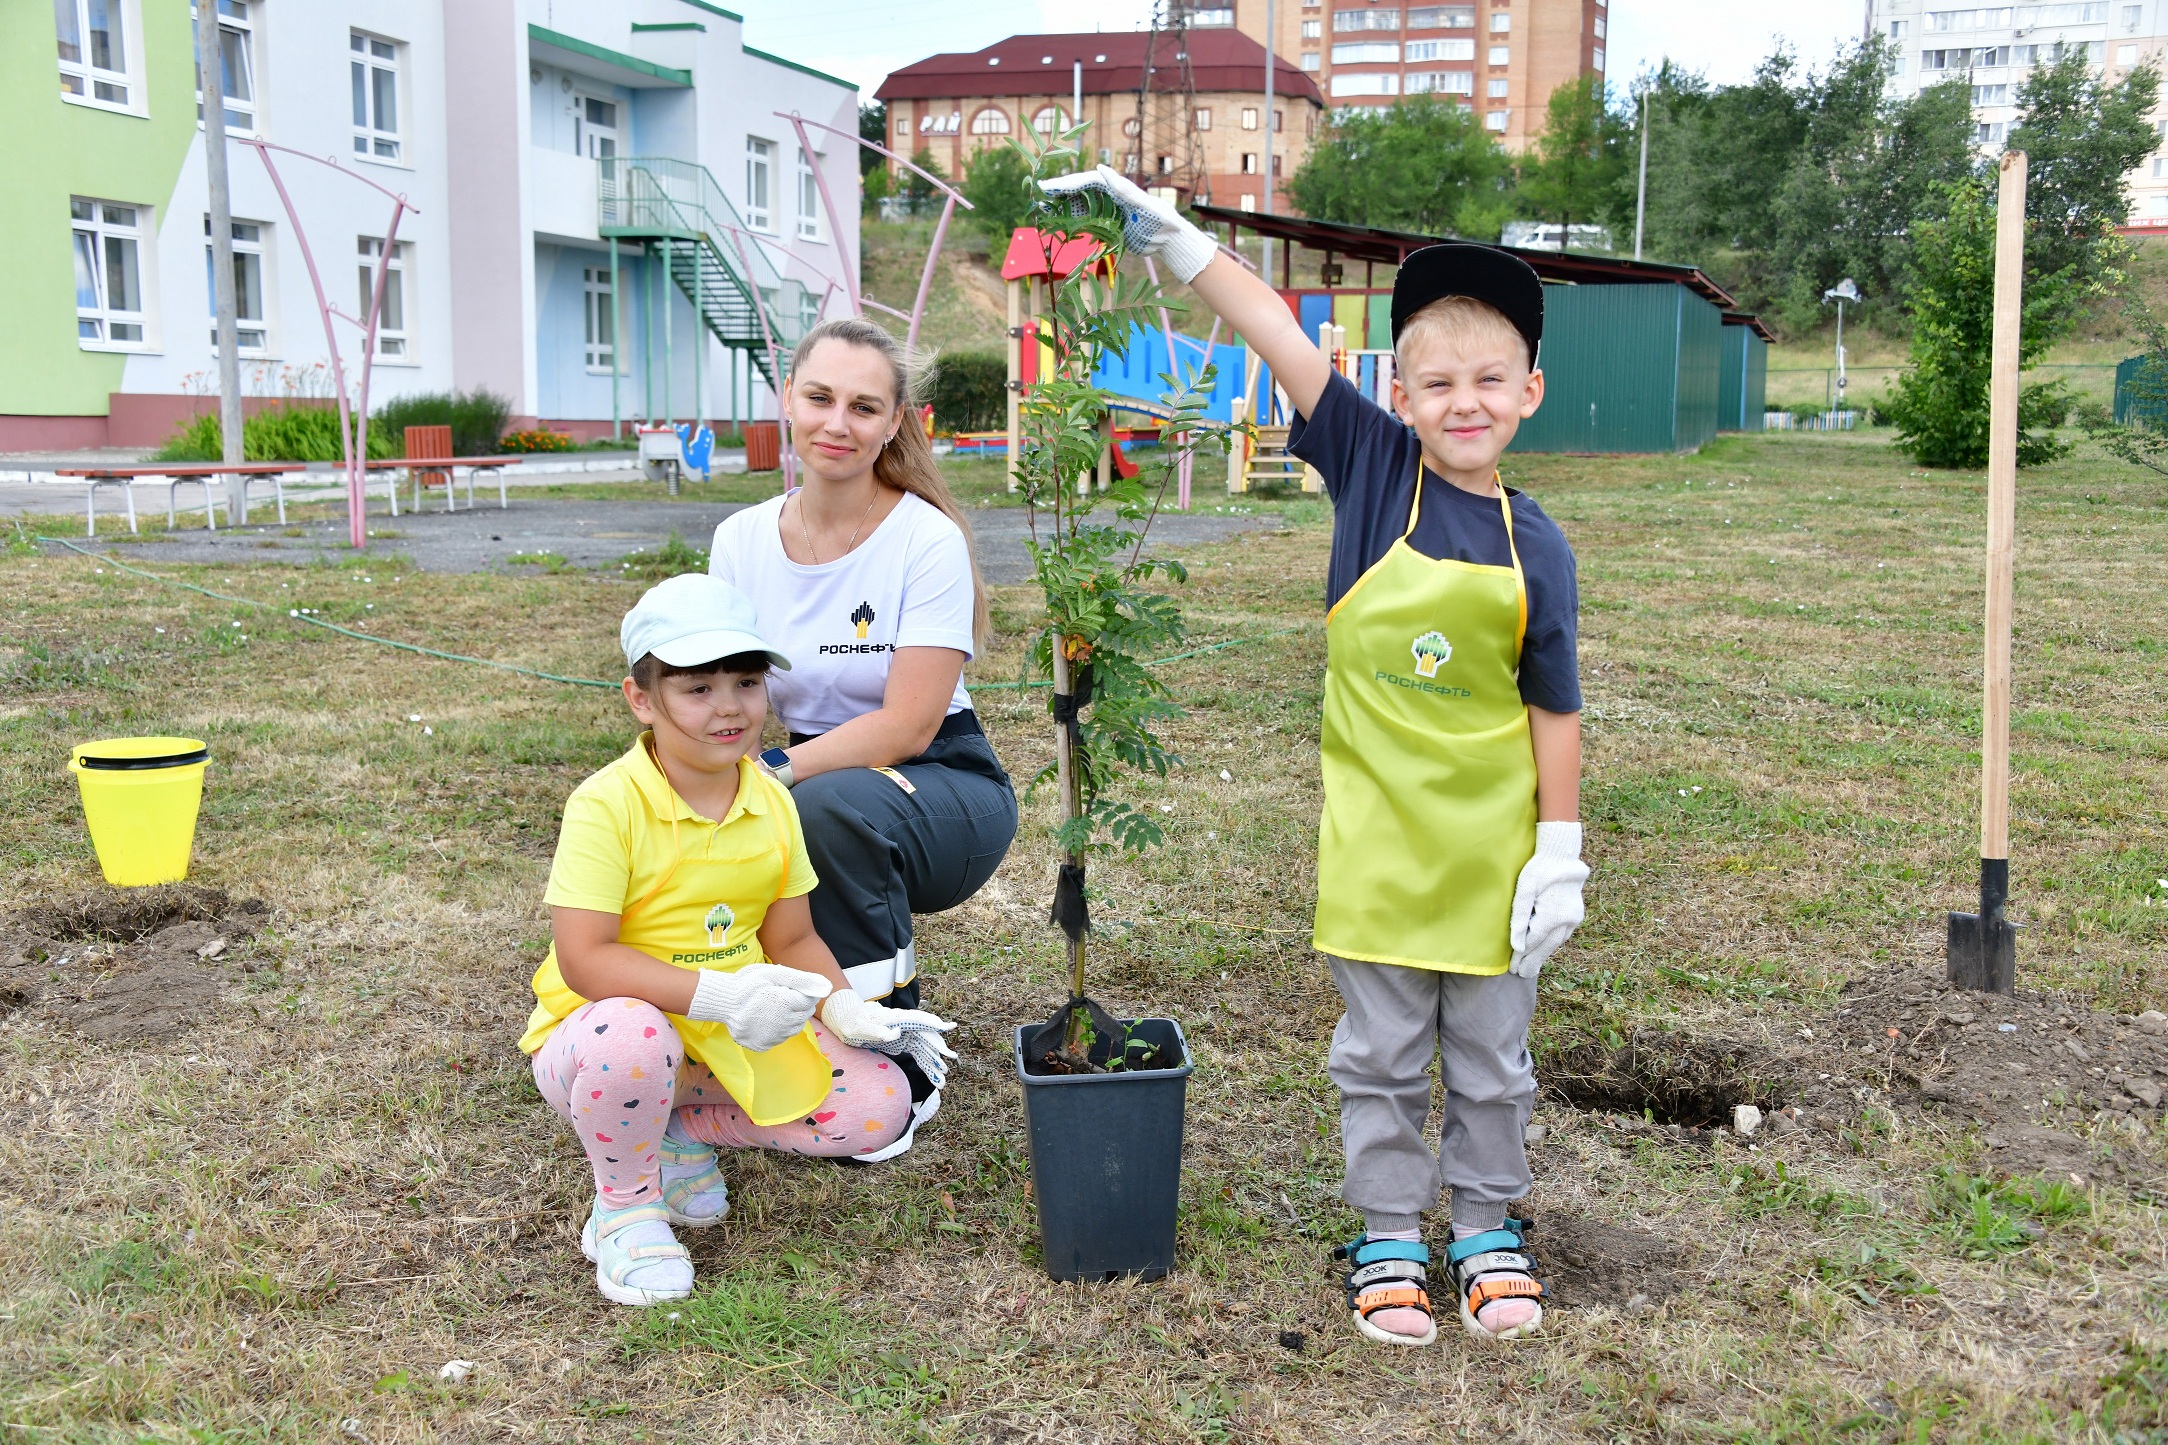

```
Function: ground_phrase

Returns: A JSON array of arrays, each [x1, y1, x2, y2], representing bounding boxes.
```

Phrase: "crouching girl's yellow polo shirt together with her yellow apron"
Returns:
[[520, 732, 833, 1124]]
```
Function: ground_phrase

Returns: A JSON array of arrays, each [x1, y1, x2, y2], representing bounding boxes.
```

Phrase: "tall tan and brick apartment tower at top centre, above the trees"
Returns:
[[1292, 0, 1611, 154]]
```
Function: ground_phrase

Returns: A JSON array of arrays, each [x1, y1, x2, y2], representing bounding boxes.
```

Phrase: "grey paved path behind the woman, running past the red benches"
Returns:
[[25, 487, 1279, 583]]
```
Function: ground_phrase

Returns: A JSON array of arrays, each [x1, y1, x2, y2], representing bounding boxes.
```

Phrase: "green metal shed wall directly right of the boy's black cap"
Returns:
[[1511, 284, 1724, 453]]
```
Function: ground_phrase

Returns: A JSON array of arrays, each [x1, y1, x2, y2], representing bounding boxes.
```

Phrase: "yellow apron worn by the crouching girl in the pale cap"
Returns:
[[522, 771, 835, 1124]]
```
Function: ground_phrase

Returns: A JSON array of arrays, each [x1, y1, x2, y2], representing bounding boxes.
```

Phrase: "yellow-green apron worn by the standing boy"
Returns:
[[1314, 470, 1535, 975]]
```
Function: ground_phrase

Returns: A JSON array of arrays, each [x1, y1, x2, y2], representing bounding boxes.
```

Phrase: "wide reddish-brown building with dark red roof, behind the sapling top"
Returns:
[[874, 30, 1325, 210]]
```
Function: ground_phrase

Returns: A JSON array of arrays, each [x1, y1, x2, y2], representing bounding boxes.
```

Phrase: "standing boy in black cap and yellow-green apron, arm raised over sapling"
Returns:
[[1047, 167, 1589, 1345]]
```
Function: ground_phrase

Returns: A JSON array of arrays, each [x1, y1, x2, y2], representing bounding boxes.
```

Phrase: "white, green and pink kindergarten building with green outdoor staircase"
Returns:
[[0, 0, 859, 451]]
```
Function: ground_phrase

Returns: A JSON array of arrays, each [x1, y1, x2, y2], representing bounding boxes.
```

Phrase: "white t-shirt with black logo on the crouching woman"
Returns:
[[707, 492, 971, 732]]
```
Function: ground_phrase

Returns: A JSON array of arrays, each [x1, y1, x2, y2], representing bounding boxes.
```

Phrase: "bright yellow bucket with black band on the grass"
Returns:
[[67, 737, 210, 888]]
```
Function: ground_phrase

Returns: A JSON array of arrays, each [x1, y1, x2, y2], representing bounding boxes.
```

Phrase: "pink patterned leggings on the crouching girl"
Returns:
[[533, 999, 911, 1209]]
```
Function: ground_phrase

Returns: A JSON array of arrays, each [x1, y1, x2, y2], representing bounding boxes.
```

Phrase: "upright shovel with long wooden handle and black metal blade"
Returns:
[[1949, 149, 2025, 994]]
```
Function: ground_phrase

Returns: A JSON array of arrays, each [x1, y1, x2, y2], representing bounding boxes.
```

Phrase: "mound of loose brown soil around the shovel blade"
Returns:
[[1802, 966, 2168, 1179]]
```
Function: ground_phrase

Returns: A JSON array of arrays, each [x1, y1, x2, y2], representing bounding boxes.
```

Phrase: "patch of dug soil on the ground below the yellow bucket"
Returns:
[[0, 884, 271, 1044]]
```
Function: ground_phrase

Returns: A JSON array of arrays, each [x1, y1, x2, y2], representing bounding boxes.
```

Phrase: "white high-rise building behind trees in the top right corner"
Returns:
[[1869, 0, 2168, 225]]
